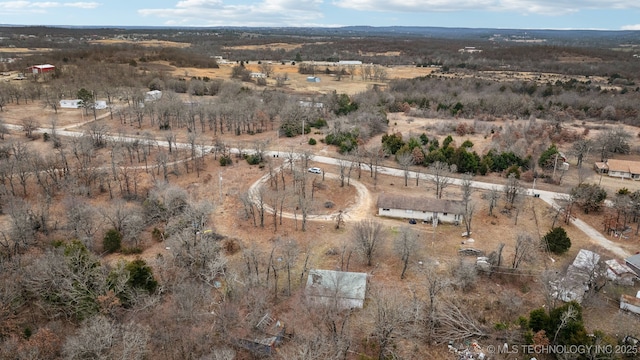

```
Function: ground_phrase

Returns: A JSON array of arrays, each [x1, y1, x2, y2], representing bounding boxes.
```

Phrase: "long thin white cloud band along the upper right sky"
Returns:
[[333, 0, 640, 16]]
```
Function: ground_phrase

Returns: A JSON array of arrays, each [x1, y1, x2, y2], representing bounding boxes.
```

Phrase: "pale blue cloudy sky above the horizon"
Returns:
[[0, 0, 640, 30]]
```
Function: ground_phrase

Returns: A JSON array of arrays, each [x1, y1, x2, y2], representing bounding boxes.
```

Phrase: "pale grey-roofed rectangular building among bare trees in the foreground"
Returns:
[[305, 269, 367, 309]]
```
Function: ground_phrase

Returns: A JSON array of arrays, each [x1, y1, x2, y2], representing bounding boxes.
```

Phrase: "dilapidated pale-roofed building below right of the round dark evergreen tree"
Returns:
[[551, 249, 600, 303]]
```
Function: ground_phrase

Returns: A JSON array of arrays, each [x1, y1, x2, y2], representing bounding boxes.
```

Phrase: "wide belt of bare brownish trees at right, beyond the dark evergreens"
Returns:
[[389, 75, 640, 124]]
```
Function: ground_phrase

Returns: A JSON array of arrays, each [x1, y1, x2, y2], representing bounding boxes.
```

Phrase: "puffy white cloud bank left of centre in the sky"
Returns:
[[138, 0, 324, 26]]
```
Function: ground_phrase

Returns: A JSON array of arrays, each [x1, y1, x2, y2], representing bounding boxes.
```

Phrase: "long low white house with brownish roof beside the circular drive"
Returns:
[[377, 193, 464, 224]]
